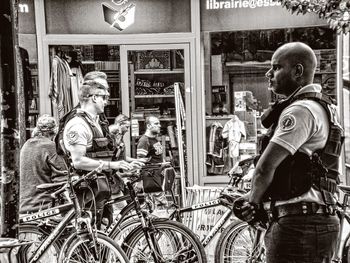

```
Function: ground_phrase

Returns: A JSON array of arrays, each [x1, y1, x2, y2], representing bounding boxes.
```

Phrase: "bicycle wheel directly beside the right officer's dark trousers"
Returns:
[[215, 221, 266, 263]]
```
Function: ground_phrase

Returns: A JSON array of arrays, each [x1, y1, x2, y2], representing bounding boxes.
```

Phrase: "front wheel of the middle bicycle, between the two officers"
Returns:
[[122, 219, 207, 263]]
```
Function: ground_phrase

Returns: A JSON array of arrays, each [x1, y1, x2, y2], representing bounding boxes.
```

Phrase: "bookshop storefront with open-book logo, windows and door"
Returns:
[[20, 0, 349, 192]]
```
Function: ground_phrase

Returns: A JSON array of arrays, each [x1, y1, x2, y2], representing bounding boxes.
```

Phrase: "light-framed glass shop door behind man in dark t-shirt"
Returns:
[[121, 44, 192, 204]]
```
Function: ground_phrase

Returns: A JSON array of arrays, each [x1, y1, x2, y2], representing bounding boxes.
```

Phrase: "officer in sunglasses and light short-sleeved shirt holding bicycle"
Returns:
[[63, 80, 142, 228]]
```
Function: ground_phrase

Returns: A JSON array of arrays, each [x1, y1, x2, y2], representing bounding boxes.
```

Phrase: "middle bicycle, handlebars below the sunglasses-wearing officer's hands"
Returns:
[[52, 164, 207, 263]]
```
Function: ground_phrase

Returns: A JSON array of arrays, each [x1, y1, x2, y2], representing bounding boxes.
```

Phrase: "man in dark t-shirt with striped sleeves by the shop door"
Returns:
[[136, 116, 168, 207]]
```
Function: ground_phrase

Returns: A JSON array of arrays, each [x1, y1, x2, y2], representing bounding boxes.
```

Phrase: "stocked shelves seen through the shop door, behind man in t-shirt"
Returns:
[[130, 50, 186, 172]]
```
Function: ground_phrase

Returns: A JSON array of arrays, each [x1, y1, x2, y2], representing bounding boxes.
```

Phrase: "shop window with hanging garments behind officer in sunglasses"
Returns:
[[48, 45, 121, 124]]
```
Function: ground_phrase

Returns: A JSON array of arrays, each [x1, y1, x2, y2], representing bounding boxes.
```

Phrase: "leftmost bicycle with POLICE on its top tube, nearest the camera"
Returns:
[[19, 166, 129, 263]]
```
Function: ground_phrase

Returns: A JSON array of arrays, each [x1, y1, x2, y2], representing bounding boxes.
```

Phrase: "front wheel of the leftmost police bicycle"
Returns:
[[58, 232, 129, 263]]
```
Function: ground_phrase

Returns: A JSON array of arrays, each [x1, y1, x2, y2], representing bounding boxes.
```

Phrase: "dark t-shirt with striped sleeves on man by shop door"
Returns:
[[136, 134, 163, 163]]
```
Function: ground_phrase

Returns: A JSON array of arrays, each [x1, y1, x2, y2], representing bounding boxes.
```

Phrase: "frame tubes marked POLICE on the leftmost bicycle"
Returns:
[[19, 203, 75, 263]]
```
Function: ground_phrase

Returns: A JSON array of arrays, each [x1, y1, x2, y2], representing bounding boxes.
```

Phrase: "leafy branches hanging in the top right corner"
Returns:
[[275, 0, 350, 34]]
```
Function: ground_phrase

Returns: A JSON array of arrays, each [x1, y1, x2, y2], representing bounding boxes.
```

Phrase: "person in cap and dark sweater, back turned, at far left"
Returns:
[[19, 115, 67, 214]]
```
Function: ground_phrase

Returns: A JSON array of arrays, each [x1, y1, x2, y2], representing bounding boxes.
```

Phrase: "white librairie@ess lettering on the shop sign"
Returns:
[[206, 0, 281, 10]]
